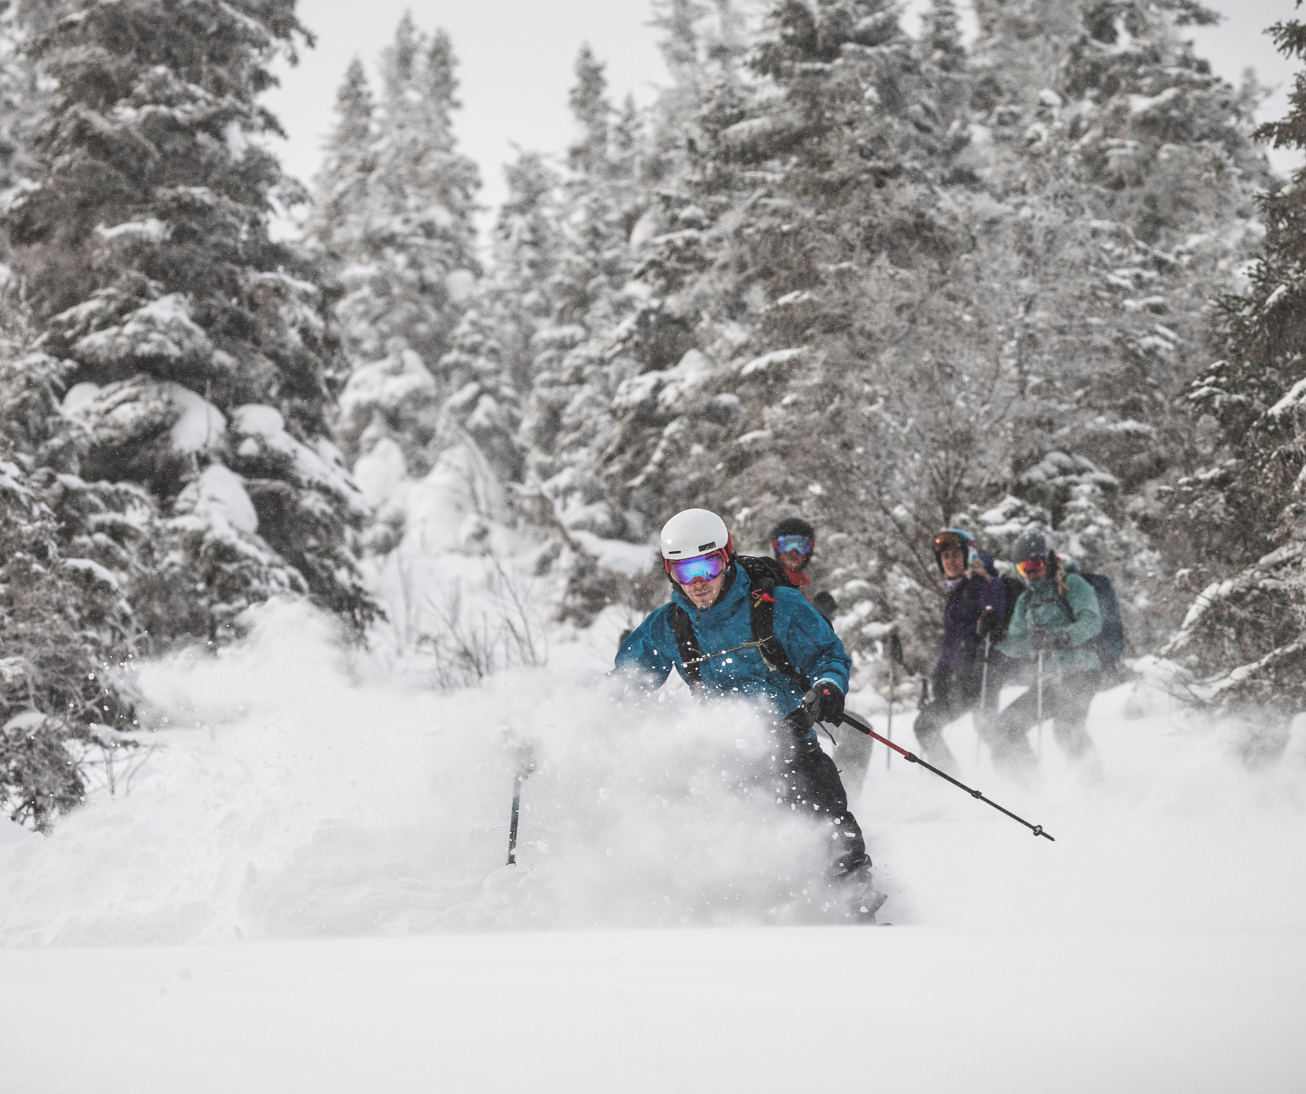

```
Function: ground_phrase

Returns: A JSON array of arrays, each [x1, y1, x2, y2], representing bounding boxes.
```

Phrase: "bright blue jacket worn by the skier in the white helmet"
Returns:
[[615, 567, 852, 735]]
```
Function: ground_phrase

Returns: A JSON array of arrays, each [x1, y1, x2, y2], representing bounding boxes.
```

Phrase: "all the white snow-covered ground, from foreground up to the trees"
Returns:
[[0, 483, 1306, 1094]]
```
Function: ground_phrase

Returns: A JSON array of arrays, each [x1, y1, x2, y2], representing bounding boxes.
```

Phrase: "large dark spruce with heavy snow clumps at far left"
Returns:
[[4, 0, 374, 638]]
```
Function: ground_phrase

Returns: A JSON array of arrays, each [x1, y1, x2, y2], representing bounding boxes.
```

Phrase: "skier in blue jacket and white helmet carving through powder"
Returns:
[[615, 509, 878, 915]]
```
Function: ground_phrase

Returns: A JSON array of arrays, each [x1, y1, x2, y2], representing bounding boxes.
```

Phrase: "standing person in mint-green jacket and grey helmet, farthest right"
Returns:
[[993, 531, 1102, 774]]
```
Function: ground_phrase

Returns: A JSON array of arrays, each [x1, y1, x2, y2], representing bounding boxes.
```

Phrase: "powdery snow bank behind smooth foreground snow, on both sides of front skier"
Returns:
[[0, 595, 1306, 945]]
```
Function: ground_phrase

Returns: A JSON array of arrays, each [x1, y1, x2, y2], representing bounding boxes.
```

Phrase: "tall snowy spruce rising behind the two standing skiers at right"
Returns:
[[940, 0, 1268, 649]]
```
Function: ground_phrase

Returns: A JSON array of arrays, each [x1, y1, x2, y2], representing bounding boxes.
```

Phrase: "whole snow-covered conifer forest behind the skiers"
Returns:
[[0, 0, 1306, 825]]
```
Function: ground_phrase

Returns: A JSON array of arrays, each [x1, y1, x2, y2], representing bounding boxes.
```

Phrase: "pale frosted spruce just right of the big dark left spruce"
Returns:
[[331, 14, 481, 477]]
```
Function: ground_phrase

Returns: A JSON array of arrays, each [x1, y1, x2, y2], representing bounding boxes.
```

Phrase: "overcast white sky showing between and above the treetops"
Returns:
[[259, 0, 1306, 236]]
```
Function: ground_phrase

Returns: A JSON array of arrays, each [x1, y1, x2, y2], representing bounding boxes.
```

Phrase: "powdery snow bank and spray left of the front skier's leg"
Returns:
[[0, 595, 846, 944]]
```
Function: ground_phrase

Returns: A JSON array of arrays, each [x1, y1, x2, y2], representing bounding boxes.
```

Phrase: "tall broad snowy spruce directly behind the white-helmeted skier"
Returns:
[[577, 4, 983, 660]]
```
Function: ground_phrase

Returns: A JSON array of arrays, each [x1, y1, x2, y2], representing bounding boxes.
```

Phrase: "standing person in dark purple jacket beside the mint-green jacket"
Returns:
[[914, 527, 1007, 772]]
